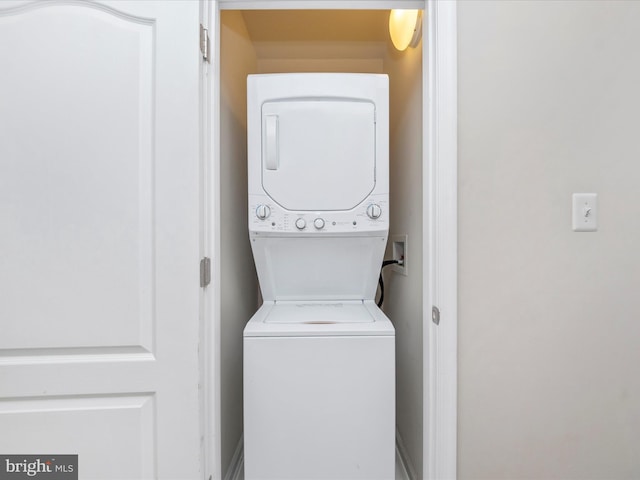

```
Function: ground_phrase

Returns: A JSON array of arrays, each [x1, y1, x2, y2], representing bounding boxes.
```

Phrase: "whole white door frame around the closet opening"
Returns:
[[200, 0, 458, 479]]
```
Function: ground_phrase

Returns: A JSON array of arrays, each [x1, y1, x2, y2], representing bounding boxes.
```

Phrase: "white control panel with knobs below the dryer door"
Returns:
[[249, 195, 389, 234]]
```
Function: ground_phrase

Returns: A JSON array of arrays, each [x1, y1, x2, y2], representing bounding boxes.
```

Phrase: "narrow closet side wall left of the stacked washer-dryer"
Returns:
[[220, 12, 258, 476]]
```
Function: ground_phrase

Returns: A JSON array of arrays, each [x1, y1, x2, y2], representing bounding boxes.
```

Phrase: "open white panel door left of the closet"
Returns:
[[0, 0, 202, 479]]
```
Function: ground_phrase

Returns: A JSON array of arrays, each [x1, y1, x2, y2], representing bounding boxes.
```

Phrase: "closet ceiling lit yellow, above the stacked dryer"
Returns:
[[242, 10, 389, 42]]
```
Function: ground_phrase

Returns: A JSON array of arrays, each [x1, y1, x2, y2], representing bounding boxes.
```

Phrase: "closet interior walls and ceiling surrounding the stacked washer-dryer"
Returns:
[[219, 10, 424, 478]]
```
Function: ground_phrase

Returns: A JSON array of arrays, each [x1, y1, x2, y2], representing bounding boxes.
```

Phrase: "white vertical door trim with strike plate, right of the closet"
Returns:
[[423, 0, 458, 480]]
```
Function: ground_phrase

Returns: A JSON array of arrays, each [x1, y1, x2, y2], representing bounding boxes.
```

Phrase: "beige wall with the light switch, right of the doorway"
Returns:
[[458, 0, 640, 479]]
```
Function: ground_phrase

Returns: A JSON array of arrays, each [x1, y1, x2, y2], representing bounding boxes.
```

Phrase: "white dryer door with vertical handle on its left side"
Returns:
[[262, 99, 376, 211]]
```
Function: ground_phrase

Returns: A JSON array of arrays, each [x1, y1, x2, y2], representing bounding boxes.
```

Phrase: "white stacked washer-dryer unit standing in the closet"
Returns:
[[244, 73, 395, 480]]
